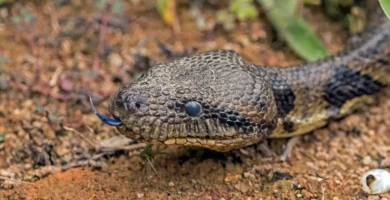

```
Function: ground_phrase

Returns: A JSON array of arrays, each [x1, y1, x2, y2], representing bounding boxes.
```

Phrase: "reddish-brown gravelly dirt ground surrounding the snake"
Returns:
[[0, 0, 390, 200]]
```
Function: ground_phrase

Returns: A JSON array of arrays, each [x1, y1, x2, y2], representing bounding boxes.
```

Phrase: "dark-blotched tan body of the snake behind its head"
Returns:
[[253, 6, 390, 137]]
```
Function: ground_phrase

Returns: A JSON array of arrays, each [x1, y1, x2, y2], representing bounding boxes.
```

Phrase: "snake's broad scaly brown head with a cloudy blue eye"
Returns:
[[109, 50, 277, 151]]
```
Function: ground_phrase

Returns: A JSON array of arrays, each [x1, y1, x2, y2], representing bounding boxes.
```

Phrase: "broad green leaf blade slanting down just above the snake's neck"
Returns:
[[258, 0, 328, 61]]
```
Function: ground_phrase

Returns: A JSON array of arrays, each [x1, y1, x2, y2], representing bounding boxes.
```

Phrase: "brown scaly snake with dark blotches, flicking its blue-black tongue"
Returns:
[[91, 2, 390, 152]]
